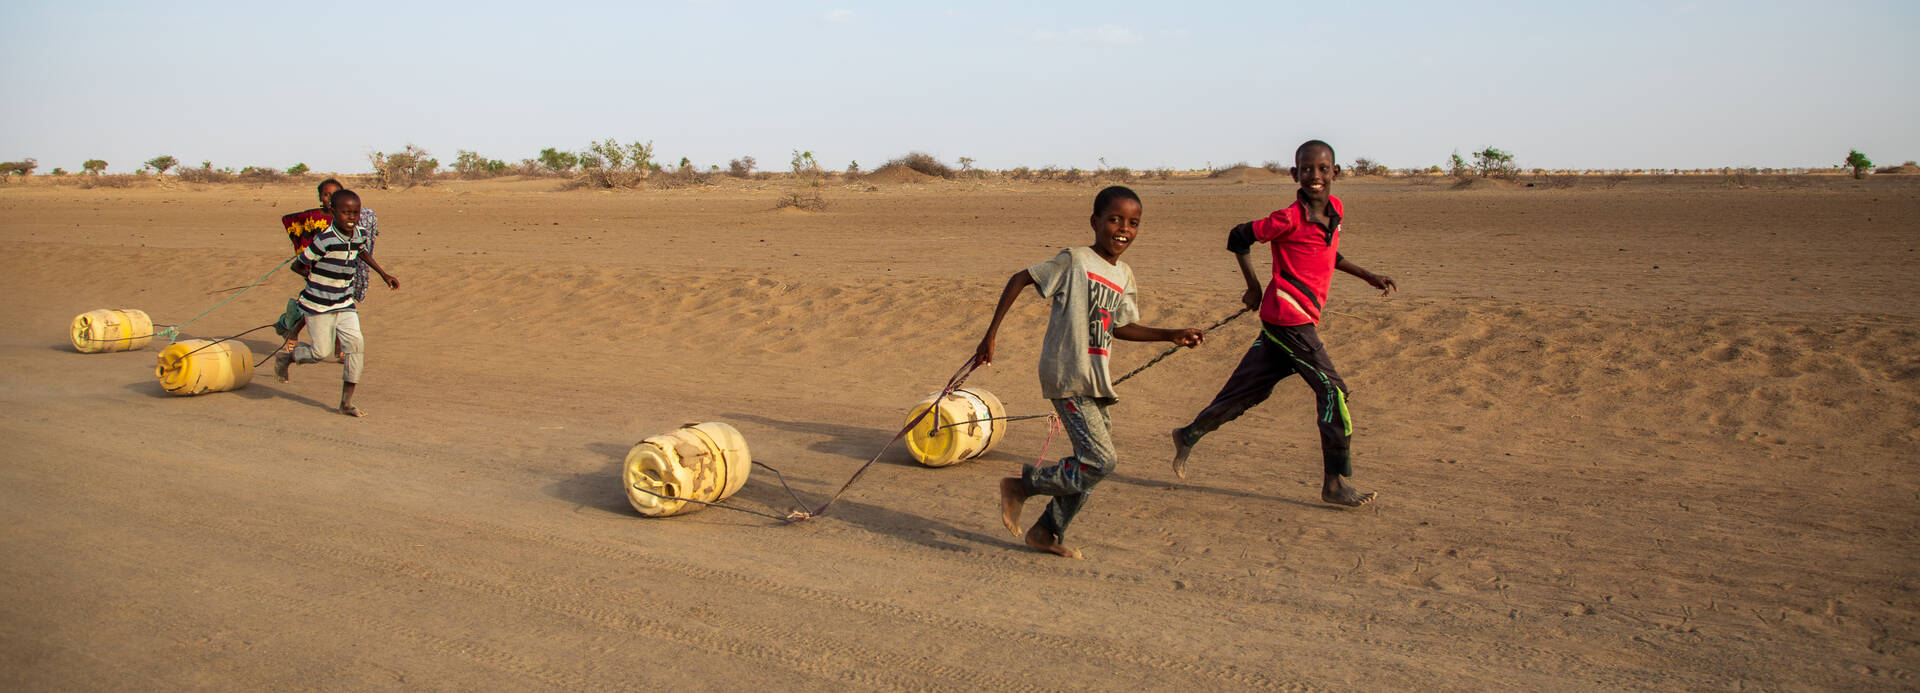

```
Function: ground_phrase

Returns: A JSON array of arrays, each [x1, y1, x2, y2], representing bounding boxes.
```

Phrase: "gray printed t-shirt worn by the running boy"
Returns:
[[1027, 246, 1140, 399]]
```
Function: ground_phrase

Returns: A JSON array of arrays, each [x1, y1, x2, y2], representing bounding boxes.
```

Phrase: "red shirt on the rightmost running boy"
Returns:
[[1248, 196, 1344, 326]]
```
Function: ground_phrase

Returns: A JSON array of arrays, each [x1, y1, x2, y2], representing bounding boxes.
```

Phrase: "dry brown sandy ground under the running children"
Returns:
[[0, 177, 1920, 691]]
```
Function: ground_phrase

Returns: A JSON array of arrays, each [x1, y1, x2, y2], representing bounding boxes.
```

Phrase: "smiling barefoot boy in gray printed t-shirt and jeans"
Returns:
[[973, 186, 1204, 559]]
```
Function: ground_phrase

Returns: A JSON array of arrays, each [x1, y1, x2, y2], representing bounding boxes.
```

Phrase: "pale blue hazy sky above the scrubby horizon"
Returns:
[[0, 0, 1920, 173]]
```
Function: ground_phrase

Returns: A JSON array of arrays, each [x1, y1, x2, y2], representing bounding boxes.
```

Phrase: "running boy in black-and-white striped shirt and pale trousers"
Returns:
[[273, 190, 399, 417]]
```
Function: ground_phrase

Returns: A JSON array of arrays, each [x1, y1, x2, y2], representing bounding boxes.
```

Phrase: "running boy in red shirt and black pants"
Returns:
[[1173, 140, 1398, 507]]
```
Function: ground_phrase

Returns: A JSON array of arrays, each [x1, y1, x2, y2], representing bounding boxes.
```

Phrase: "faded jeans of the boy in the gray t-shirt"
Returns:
[[1020, 397, 1119, 541]]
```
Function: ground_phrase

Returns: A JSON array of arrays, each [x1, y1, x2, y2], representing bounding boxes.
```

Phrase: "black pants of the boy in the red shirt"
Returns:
[[1181, 324, 1354, 476]]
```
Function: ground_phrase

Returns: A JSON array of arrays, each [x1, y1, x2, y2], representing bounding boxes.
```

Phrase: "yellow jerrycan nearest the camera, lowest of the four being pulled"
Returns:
[[620, 422, 753, 516]]
